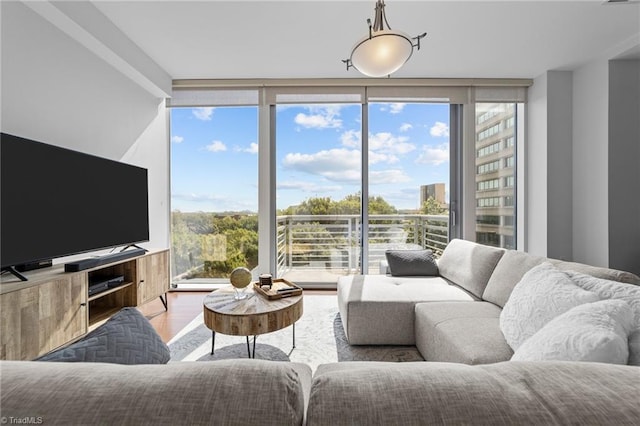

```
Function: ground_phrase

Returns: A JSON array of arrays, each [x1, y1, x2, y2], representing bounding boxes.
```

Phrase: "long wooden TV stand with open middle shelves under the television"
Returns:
[[0, 249, 169, 360]]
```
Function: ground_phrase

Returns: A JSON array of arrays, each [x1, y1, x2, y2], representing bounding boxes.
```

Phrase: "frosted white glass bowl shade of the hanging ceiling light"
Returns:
[[351, 30, 413, 77]]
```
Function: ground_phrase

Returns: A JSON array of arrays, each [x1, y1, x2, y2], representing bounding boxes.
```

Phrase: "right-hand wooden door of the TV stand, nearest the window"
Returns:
[[137, 250, 169, 305]]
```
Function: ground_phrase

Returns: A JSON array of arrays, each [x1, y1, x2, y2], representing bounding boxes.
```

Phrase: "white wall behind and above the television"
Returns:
[[0, 2, 169, 255]]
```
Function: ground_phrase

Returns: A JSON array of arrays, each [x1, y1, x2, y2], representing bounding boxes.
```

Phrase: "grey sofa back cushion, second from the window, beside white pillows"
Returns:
[[482, 250, 546, 307]]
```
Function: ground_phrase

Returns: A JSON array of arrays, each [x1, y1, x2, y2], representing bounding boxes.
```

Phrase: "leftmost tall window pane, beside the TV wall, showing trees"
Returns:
[[170, 107, 258, 288]]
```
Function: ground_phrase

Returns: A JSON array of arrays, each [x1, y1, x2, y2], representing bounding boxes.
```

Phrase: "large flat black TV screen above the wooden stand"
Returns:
[[0, 133, 149, 268]]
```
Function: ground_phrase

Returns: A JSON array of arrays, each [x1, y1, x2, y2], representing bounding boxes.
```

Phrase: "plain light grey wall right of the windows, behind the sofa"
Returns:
[[526, 48, 640, 273]]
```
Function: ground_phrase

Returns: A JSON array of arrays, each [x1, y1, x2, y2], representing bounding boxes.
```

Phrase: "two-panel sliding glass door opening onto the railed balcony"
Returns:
[[275, 102, 450, 285]]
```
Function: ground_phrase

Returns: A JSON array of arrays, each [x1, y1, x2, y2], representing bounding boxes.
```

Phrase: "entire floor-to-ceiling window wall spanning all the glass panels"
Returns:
[[169, 80, 528, 286]]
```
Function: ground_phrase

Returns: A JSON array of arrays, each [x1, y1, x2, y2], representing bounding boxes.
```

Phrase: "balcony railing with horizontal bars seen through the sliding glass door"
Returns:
[[277, 214, 449, 276]]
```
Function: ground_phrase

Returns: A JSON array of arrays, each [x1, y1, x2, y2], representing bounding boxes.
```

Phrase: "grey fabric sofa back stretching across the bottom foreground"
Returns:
[[0, 359, 640, 426]]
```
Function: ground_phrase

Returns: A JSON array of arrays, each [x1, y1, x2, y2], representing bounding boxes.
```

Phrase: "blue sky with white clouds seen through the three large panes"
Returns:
[[171, 103, 449, 212]]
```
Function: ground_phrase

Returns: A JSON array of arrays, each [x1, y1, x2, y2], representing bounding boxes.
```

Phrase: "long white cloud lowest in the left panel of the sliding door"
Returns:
[[282, 148, 360, 182]]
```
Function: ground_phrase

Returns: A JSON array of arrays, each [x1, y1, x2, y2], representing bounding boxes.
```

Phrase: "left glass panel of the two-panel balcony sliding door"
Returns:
[[275, 103, 362, 284]]
